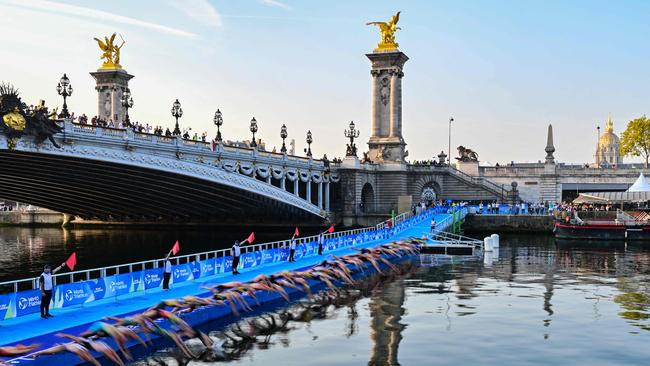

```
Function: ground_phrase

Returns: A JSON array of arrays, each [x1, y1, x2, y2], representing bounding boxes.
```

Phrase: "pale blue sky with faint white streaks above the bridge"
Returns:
[[0, 0, 650, 163]]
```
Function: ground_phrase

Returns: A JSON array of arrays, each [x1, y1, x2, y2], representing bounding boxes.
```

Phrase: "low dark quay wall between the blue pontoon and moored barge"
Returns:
[[463, 215, 555, 233]]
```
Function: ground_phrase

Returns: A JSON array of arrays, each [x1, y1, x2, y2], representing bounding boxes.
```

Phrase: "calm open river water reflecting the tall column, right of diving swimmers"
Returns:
[[129, 236, 650, 365]]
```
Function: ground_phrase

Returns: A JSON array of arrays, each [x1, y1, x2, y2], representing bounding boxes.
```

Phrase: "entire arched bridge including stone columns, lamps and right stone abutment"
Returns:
[[0, 30, 512, 225]]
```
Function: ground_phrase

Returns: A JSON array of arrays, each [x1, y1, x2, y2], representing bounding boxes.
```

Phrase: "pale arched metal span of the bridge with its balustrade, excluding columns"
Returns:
[[0, 119, 339, 222]]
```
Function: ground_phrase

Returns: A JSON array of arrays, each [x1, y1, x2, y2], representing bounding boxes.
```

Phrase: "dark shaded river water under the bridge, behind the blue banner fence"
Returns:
[[0, 227, 308, 282]]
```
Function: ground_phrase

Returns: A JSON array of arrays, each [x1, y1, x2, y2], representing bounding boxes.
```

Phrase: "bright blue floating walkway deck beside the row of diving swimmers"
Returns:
[[0, 214, 450, 365]]
